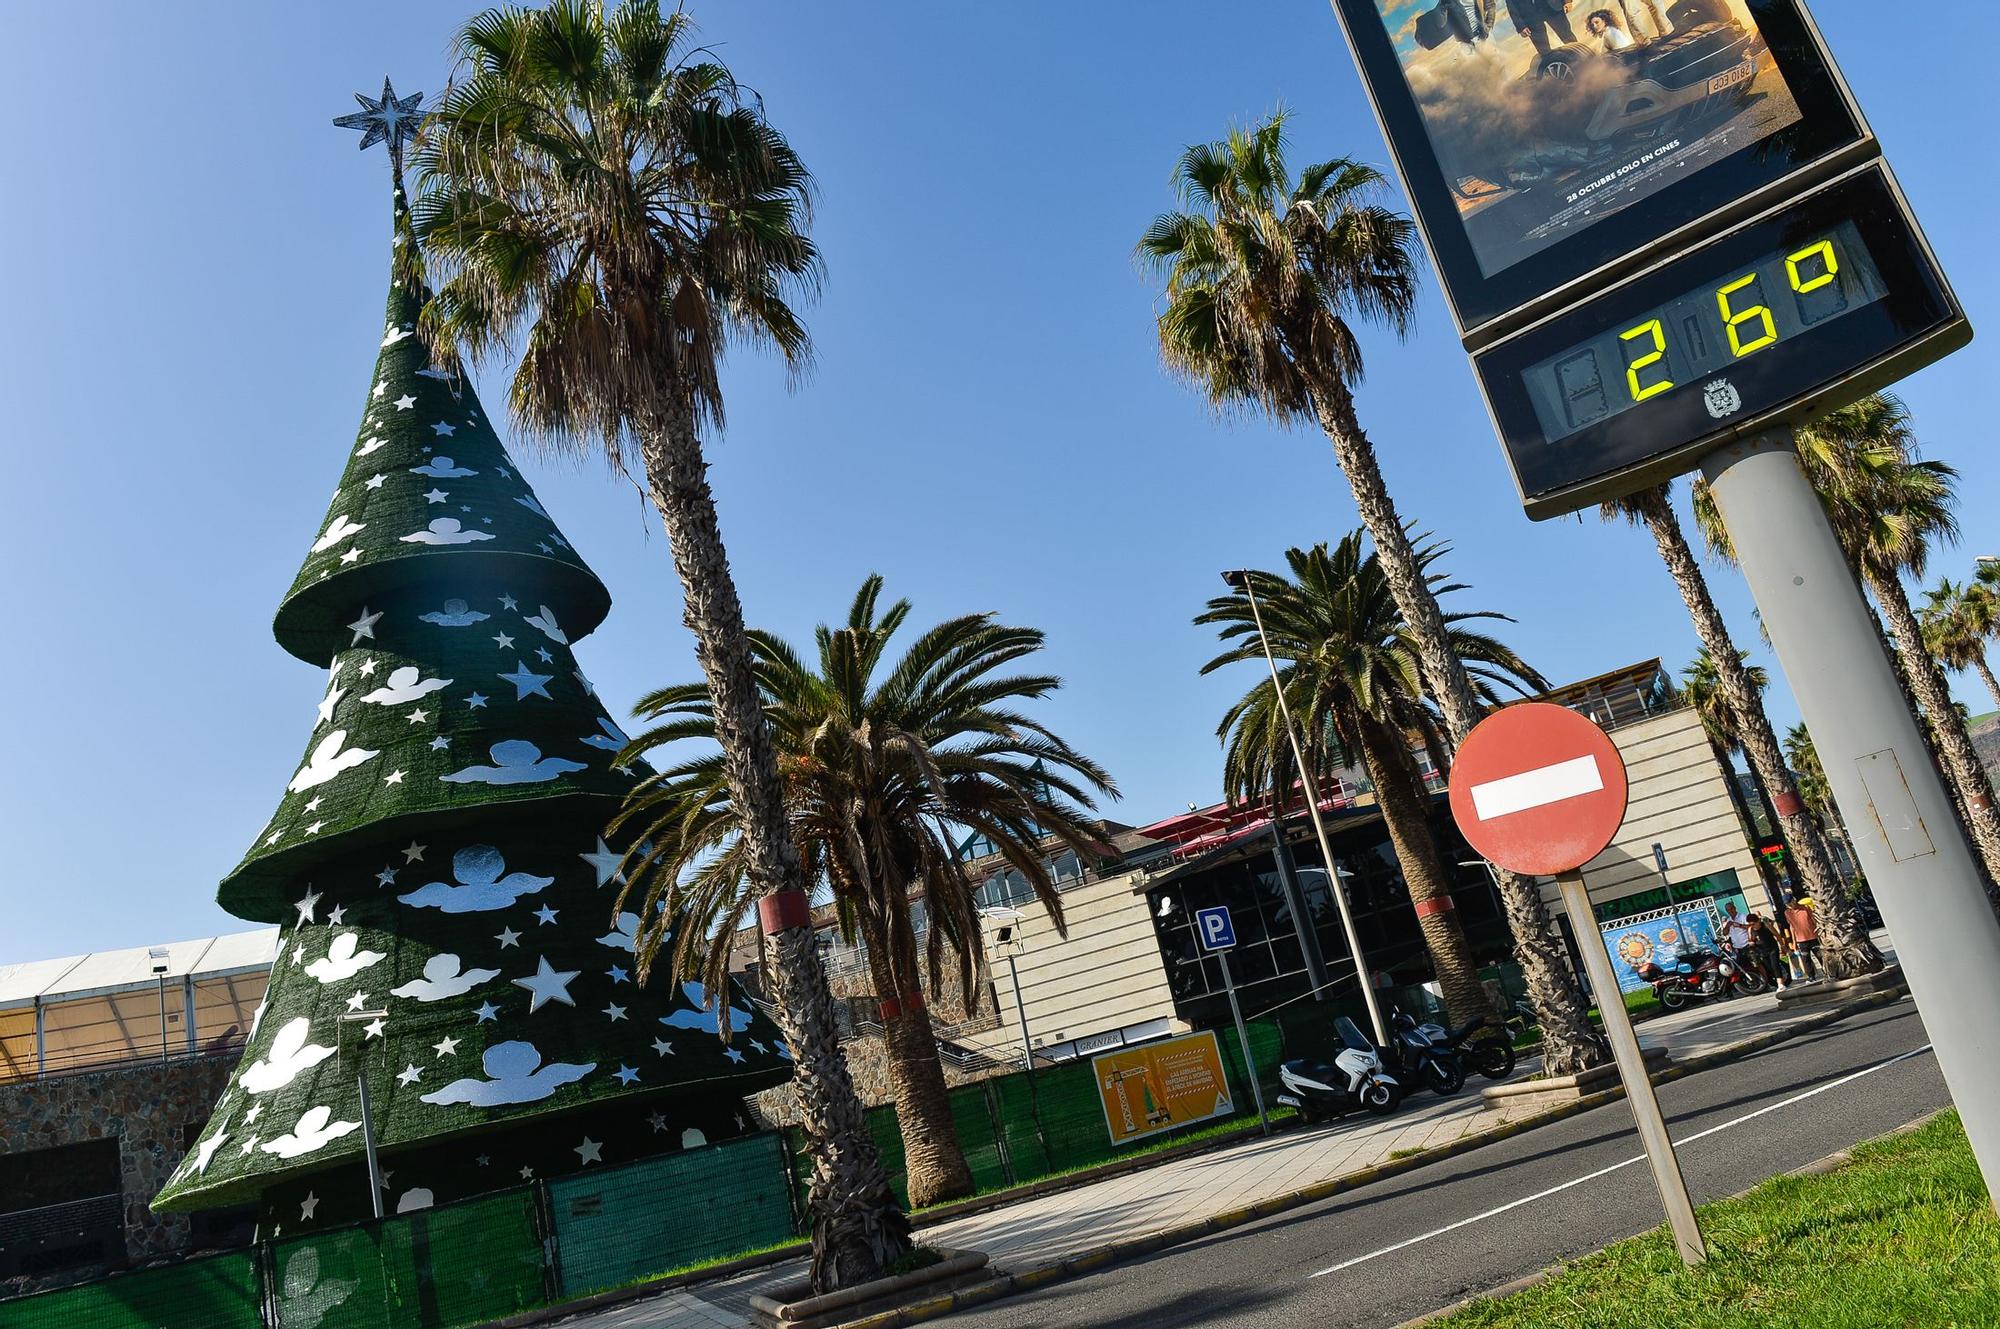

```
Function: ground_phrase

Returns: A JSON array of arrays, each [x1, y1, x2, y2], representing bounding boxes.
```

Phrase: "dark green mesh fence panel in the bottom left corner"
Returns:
[[0, 1251, 264, 1329]]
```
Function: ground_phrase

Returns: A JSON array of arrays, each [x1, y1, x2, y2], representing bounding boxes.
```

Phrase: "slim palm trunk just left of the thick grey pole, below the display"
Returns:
[[1630, 484, 1882, 979]]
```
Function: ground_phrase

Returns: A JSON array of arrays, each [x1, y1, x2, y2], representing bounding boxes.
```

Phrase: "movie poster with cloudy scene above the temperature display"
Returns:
[[1372, 0, 1802, 276]]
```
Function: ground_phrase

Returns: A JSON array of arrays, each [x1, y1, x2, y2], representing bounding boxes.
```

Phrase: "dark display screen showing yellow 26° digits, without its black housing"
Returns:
[[1524, 222, 1888, 442]]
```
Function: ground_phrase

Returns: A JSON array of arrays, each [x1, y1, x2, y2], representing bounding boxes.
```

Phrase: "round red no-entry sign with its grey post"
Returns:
[[1452, 703, 1708, 1265]]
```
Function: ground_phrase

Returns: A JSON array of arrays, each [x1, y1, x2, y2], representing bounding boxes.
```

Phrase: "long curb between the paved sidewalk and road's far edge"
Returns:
[[836, 987, 1920, 1329]]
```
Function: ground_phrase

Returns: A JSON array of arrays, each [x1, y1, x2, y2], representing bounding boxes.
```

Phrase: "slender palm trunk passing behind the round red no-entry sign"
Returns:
[[1314, 380, 1610, 1075]]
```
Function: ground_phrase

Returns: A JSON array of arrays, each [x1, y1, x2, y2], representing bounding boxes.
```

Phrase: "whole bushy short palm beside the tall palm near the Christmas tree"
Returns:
[[614, 576, 1116, 1207]]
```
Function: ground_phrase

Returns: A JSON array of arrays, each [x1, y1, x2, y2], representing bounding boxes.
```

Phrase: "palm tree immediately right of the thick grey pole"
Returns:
[[1798, 392, 2000, 883]]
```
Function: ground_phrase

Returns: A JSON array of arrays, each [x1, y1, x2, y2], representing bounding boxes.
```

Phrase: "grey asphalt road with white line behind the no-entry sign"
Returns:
[[952, 1001, 1950, 1329]]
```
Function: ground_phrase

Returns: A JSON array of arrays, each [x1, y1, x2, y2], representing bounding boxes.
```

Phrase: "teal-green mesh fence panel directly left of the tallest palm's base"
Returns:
[[548, 1135, 796, 1299]]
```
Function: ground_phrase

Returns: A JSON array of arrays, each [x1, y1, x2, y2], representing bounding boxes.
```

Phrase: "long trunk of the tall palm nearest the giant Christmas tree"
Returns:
[[638, 400, 910, 1293]]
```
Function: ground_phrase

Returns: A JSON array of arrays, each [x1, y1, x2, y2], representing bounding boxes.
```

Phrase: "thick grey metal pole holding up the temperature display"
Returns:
[[1702, 432, 2000, 1197]]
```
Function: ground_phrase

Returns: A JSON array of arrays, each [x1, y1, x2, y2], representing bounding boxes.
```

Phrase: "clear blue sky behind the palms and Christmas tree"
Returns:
[[0, 0, 2000, 963]]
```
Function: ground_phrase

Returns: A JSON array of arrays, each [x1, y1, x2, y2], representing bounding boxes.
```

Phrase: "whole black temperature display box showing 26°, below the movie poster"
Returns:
[[1472, 162, 1972, 518]]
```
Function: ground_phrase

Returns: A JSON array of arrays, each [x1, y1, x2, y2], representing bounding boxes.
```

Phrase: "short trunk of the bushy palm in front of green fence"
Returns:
[[862, 908, 972, 1209]]
